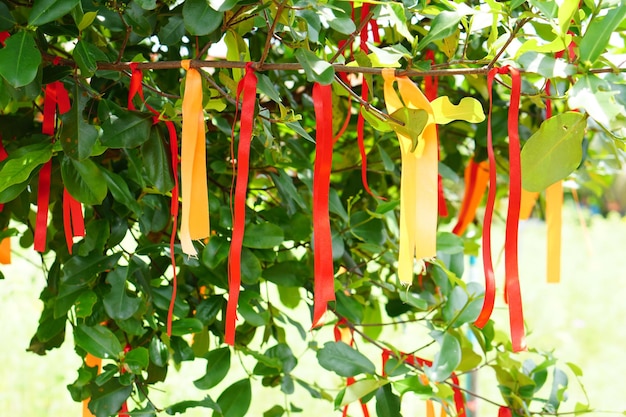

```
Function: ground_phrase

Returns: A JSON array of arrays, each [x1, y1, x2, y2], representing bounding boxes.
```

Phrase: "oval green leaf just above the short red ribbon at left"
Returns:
[[61, 157, 107, 205]]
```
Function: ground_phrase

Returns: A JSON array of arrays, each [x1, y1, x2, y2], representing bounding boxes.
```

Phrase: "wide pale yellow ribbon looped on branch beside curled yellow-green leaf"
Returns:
[[382, 68, 438, 283]]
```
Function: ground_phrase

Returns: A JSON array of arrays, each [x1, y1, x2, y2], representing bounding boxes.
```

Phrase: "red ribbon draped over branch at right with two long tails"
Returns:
[[475, 66, 526, 352]]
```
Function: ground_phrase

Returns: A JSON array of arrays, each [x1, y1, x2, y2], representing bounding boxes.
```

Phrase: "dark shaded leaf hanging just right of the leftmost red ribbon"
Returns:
[[59, 83, 98, 160]]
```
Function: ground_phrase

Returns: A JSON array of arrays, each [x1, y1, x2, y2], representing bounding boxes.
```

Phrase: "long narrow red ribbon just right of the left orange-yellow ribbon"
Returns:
[[224, 62, 257, 345]]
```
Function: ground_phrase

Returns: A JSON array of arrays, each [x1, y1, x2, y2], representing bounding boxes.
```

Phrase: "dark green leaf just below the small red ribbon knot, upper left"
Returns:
[[98, 101, 152, 148]]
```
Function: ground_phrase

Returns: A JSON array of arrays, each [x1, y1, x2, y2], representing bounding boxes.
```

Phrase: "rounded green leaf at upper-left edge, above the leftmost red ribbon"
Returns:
[[0, 31, 41, 88]]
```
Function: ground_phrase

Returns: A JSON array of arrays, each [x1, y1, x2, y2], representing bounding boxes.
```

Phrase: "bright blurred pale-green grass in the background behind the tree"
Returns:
[[0, 202, 626, 417]]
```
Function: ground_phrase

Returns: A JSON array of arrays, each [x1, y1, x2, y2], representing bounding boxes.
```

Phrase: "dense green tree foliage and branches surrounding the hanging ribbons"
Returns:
[[0, 0, 626, 417]]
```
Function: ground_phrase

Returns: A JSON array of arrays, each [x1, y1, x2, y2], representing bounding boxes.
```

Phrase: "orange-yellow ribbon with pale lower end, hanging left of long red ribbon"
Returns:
[[180, 59, 211, 256]]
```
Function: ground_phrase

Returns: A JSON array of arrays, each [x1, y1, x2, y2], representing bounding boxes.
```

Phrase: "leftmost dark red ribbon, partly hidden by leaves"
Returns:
[[34, 81, 71, 253]]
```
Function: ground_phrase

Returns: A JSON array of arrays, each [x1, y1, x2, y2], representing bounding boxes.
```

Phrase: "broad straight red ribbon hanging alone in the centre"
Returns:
[[313, 83, 335, 327]]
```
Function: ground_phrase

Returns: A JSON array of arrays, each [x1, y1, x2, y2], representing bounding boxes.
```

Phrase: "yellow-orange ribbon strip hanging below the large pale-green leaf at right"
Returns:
[[546, 181, 563, 283]]
